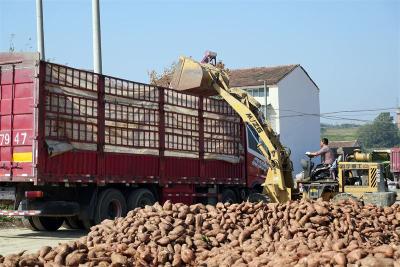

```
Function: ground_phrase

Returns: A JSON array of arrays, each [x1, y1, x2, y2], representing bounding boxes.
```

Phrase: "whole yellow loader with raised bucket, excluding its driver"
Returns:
[[170, 52, 396, 205]]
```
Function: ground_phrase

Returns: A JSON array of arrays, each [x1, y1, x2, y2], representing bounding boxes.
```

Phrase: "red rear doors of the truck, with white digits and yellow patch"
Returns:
[[0, 59, 36, 181]]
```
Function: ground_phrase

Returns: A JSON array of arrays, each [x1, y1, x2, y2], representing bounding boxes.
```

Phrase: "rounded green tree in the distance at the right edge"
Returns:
[[358, 112, 400, 148]]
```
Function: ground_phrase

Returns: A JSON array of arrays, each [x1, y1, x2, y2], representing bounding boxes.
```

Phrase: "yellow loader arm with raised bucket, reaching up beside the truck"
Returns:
[[170, 57, 293, 202]]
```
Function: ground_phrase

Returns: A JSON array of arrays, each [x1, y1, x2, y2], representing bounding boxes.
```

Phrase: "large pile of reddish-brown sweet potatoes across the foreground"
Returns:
[[0, 200, 400, 267]]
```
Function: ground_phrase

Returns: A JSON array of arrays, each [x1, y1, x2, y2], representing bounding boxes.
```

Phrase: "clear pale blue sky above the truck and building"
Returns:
[[0, 0, 400, 122]]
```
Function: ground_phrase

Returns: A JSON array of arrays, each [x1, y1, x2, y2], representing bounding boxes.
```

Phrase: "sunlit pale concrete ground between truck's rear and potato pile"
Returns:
[[0, 228, 87, 255]]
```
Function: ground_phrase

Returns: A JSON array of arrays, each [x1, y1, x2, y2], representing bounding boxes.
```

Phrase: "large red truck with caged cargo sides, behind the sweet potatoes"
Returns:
[[0, 53, 266, 230]]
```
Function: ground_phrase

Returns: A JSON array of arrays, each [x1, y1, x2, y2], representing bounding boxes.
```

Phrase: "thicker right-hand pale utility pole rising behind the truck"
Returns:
[[92, 0, 102, 74]]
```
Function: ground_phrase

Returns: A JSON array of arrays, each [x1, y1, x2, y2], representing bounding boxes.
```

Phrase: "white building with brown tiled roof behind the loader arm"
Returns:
[[229, 65, 320, 173]]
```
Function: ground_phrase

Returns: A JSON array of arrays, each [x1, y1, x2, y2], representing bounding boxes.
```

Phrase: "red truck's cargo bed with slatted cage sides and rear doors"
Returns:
[[0, 53, 246, 185]]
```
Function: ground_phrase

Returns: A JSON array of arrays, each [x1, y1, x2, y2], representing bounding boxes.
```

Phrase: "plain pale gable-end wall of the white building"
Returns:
[[271, 67, 320, 173]]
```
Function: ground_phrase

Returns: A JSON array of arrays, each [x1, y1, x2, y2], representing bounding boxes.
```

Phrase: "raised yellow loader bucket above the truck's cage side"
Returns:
[[169, 57, 228, 96]]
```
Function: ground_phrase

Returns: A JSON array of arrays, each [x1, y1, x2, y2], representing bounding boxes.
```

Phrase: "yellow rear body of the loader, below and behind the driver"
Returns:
[[300, 149, 396, 206]]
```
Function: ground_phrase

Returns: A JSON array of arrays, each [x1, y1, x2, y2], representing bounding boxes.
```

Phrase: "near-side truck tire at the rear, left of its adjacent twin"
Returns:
[[94, 188, 126, 224]]
